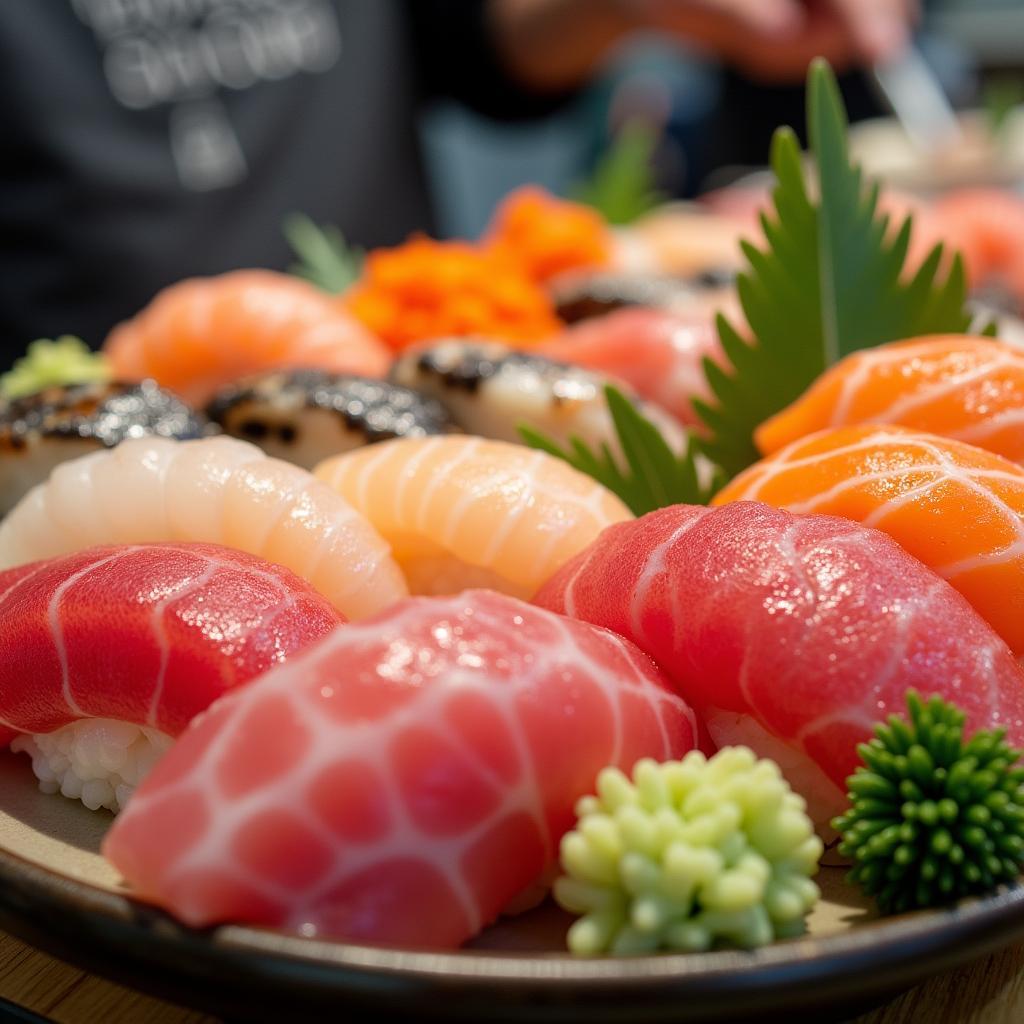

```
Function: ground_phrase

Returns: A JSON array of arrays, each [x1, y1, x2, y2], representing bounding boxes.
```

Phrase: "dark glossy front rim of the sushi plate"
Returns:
[[0, 847, 1024, 1020]]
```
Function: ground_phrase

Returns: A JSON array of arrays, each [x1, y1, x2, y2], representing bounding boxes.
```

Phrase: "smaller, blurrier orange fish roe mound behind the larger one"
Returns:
[[484, 185, 612, 283]]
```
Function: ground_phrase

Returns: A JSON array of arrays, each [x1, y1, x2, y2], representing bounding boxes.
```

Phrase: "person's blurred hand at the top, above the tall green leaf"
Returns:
[[626, 0, 920, 81]]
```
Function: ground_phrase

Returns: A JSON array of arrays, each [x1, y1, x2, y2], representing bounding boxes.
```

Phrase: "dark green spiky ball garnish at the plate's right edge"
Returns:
[[833, 691, 1024, 913]]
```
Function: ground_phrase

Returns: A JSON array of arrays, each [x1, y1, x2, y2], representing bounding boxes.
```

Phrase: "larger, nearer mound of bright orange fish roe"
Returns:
[[342, 237, 562, 350]]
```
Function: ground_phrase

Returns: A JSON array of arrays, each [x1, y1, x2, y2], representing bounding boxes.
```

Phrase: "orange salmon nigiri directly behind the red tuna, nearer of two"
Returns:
[[715, 426, 1024, 655]]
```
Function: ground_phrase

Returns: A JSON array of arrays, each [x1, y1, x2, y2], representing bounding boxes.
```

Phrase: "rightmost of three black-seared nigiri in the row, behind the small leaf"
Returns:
[[391, 338, 687, 452]]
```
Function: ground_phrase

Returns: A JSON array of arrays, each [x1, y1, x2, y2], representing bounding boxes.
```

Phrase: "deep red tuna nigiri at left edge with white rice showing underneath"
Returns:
[[0, 544, 344, 810]]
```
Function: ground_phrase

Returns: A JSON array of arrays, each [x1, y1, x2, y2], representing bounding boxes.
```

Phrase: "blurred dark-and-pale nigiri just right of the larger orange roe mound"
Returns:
[[552, 268, 735, 324]]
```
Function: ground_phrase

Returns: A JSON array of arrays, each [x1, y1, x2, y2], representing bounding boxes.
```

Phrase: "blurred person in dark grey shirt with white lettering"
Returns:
[[0, 0, 915, 364]]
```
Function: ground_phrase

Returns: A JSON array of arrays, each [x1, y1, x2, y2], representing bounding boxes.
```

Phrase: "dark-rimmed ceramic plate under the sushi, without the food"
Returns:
[[6, 753, 1024, 1024]]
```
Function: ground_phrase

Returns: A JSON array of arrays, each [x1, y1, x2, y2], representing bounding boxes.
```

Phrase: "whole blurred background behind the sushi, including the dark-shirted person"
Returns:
[[0, 0, 1024, 362]]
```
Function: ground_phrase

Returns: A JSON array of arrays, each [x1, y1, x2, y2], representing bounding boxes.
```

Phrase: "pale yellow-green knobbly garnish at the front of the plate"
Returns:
[[555, 746, 822, 954]]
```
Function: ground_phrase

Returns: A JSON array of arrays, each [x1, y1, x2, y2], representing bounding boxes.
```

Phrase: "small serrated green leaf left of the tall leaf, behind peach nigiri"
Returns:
[[519, 384, 723, 515]]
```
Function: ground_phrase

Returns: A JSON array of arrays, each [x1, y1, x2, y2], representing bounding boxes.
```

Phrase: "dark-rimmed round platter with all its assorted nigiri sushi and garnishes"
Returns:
[[0, 62, 1024, 1022]]
